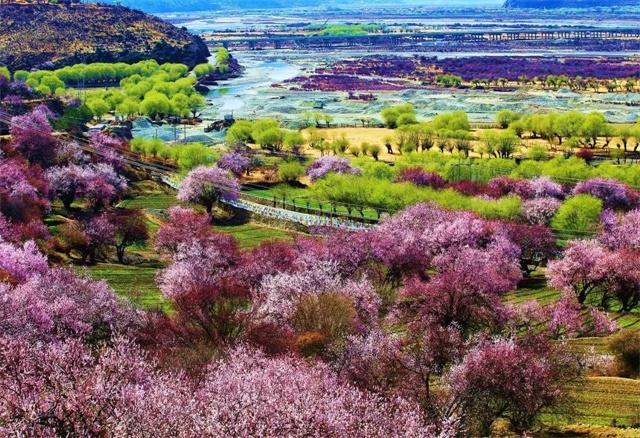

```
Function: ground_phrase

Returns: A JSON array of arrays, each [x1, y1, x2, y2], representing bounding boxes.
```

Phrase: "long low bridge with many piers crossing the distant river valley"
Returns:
[[207, 28, 640, 50]]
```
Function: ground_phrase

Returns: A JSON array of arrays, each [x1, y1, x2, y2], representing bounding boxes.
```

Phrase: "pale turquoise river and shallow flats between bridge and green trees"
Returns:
[[134, 50, 640, 143]]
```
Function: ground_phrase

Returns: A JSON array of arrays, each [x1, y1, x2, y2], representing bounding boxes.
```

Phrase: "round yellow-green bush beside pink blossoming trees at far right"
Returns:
[[551, 195, 602, 234]]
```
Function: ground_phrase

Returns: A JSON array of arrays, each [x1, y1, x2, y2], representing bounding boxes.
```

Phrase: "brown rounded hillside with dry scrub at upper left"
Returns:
[[0, 4, 209, 70]]
